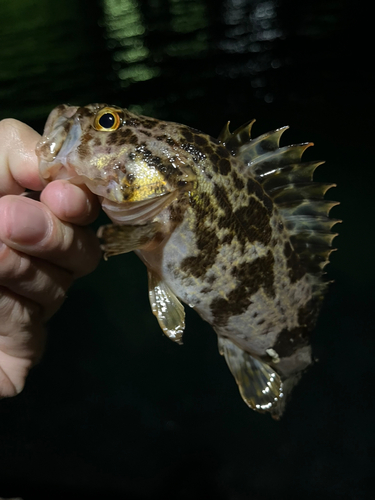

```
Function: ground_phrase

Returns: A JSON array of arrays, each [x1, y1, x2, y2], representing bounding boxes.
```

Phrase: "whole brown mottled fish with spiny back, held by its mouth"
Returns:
[[36, 104, 341, 419]]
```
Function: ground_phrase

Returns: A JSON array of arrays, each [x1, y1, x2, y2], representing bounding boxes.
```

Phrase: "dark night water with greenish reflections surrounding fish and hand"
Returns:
[[0, 0, 375, 500]]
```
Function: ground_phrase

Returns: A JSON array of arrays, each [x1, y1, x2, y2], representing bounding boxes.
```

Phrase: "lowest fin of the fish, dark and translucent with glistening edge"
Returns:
[[219, 337, 283, 417]]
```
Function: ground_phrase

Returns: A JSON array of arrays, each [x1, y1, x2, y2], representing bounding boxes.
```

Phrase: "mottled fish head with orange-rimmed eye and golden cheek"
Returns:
[[36, 104, 194, 224]]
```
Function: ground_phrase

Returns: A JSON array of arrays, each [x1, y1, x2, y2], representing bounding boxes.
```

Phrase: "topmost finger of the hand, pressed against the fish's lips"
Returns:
[[0, 118, 46, 196]]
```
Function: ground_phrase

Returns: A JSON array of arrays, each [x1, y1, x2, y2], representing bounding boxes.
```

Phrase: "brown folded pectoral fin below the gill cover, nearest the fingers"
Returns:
[[97, 222, 159, 259]]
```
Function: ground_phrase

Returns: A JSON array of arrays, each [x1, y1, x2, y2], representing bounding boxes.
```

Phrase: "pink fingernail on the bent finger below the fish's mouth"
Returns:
[[7, 197, 49, 245]]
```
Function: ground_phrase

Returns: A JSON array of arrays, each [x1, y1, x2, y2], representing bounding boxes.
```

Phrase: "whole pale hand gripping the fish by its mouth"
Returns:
[[0, 119, 101, 398]]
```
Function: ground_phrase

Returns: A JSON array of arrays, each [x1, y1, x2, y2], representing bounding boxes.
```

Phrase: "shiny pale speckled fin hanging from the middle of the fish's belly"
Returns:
[[148, 270, 185, 344]]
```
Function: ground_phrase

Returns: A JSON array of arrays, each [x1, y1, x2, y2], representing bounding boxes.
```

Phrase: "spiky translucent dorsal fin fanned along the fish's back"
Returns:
[[220, 120, 341, 280]]
